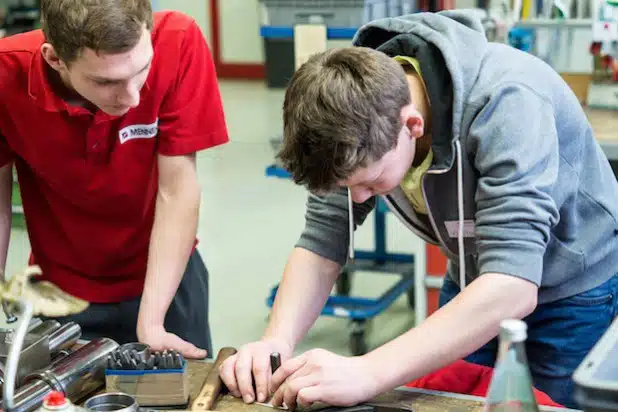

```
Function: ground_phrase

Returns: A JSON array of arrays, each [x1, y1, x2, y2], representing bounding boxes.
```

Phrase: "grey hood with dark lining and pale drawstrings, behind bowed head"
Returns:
[[348, 10, 488, 287]]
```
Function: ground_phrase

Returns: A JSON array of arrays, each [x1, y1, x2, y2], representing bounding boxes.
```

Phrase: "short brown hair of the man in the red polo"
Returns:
[[41, 0, 153, 63]]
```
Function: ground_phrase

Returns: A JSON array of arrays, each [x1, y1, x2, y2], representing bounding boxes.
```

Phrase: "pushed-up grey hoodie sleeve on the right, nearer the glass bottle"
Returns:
[[468, 84, 559, 285]]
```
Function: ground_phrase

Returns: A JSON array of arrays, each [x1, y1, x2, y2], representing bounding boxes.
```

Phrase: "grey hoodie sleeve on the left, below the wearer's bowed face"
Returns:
[[296, 189, 376, 266]]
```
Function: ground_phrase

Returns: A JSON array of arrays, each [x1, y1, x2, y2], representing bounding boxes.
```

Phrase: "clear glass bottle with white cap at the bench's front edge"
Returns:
[[485, 319, 539, 412]]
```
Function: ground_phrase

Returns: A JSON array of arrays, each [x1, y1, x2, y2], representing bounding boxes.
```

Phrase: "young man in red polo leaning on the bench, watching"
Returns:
[[0, 0, 228, 357]]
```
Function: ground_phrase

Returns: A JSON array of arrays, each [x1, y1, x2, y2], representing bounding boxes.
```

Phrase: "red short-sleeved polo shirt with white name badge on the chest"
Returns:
[[0, 12, 228, 302]]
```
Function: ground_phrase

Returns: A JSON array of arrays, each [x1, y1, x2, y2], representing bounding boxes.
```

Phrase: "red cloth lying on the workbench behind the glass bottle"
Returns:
[[405, 360, 562, 408]]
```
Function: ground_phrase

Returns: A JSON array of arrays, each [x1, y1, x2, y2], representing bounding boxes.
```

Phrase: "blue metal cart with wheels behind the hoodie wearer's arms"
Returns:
[[266, 165, 415, 355]]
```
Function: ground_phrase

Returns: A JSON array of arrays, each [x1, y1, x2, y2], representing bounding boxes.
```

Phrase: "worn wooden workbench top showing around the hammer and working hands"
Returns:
[[179, 361, 568, 412]]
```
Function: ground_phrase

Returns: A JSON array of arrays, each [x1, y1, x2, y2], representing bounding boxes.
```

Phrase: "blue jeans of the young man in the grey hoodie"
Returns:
[[440, 275, 618, 408]]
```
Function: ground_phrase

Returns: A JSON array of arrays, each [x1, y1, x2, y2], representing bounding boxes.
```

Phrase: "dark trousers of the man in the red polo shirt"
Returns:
[[45, 250, 212, 358]]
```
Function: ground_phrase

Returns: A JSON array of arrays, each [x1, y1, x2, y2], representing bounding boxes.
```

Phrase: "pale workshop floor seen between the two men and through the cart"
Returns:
[[1, 82, 424, 354]]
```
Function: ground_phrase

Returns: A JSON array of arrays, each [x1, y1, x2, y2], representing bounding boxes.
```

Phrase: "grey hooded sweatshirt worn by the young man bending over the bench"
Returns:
[[297, 11, 618, 303]]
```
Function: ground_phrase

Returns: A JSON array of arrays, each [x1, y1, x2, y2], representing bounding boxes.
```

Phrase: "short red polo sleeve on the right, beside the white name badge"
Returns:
[[158, 22, 229, 156]]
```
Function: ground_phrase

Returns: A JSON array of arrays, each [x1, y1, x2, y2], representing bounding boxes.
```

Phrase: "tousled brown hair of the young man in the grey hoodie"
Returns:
[[278, 47, 410, 192]]
